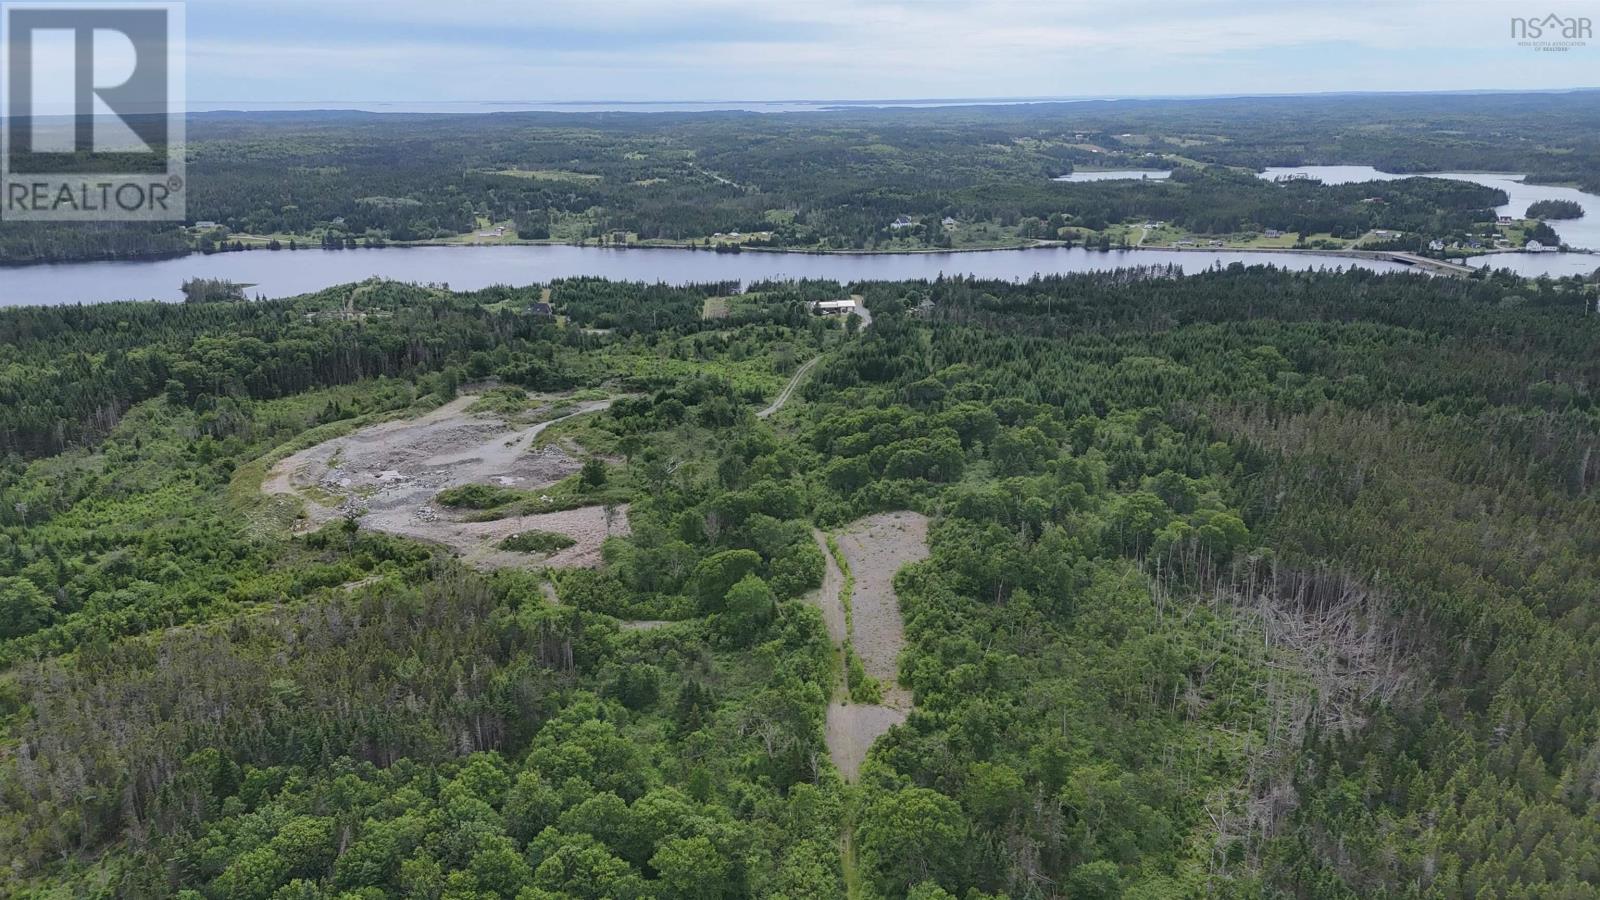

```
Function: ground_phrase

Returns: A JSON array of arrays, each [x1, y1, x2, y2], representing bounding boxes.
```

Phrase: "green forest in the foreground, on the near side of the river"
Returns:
[[0, 257, 1600, 900]]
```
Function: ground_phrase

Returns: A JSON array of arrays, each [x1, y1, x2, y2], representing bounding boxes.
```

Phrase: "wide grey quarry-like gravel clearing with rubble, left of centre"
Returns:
[[261, 396, 627, 569]]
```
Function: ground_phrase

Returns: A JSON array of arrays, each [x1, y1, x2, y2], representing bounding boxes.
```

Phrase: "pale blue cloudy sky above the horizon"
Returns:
[[175, 0, 1600, 107]]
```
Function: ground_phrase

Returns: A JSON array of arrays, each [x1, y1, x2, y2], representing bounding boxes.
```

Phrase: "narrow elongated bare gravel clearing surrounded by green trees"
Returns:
[[816, 512, 928, 781]]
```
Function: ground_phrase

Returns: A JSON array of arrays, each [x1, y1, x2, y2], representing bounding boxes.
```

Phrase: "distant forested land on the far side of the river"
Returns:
[[0, 91, 1600, 263]]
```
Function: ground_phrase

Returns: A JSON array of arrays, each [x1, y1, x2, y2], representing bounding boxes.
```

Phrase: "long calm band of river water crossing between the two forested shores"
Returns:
[[0, 245, 1427, 306]]
